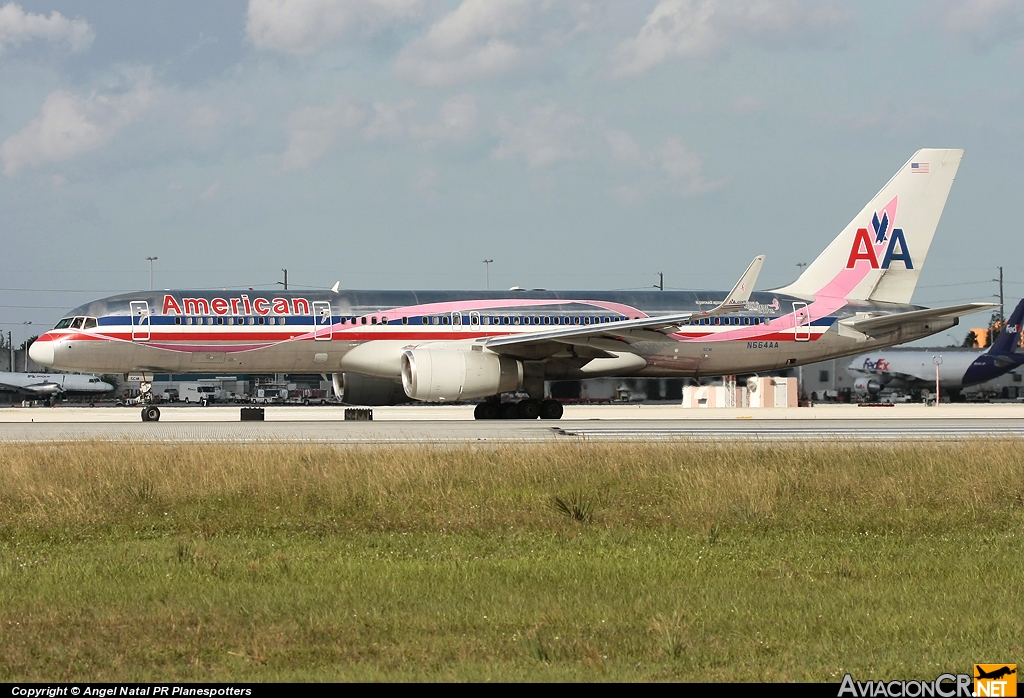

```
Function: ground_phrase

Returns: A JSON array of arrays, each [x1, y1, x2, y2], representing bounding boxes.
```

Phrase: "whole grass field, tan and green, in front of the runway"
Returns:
[[0, 441, 1024, 682]]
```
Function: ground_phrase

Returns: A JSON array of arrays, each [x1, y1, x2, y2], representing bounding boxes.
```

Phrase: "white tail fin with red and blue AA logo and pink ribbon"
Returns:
[[777, 148, 964, 303]]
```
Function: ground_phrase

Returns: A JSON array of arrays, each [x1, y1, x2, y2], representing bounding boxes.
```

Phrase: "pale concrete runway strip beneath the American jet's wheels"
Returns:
[[0, 404, 1024, 445]]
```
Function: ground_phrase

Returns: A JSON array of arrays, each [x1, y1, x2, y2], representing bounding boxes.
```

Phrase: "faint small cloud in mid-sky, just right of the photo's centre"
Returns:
[[492, 105, 586, 169]]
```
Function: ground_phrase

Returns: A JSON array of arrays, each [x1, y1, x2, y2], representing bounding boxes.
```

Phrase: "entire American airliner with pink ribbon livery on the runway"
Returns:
[[30, 149, 995, 420]]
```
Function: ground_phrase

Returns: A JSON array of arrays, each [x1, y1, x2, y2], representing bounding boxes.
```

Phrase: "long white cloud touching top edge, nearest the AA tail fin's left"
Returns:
[[612, 0, 847, 77]]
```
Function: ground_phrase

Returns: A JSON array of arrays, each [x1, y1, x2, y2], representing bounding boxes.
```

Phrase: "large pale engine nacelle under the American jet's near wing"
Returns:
[[401, 347, 522, 402]]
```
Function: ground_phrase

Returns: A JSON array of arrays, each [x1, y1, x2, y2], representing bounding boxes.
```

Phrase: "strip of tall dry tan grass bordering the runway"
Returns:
[[0, 442, 1024, 531]]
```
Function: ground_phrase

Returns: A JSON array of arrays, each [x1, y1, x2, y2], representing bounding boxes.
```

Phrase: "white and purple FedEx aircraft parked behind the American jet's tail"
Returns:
[[850, 300, 1024, 396]]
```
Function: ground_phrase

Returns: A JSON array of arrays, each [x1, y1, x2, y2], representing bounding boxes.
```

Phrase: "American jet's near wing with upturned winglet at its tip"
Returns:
[[481, 255, 765, 353]]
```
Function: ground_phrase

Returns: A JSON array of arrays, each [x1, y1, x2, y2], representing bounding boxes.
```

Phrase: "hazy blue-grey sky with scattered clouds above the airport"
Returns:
[[0, 0, 1024, 344]]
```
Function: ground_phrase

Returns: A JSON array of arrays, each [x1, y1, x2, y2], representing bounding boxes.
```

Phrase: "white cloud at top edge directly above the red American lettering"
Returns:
[[246, 0, 423, 54]]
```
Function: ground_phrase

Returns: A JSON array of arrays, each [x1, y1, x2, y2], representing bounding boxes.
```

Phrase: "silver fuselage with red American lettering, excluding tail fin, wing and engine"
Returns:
[[34, 291, 956, 380]]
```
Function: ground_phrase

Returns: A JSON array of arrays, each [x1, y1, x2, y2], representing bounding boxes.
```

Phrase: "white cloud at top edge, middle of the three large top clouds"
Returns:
[[394, 0, 534, 85]]
